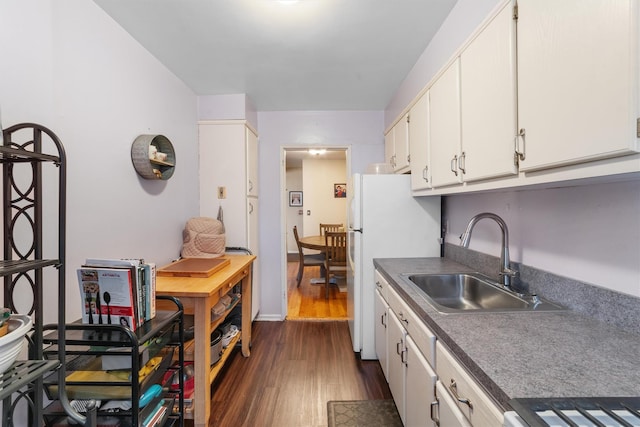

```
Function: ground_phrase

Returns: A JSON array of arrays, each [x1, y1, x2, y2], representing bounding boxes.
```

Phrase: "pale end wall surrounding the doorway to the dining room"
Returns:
[[258, 111, 384, 319]]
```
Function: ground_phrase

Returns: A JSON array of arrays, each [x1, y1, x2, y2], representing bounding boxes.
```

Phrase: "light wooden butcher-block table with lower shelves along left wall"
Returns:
[[156, 255, 256, 427]]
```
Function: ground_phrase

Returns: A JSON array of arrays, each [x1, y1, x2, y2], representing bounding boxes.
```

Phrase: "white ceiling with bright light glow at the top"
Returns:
[[94, 0, 456, 111]]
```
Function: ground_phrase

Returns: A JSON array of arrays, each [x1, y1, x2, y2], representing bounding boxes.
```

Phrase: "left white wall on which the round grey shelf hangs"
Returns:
[[0, 0, 198, 321]]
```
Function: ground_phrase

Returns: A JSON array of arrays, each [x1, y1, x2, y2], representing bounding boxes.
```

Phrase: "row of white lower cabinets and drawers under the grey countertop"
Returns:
[[375, 271, 504, 427]]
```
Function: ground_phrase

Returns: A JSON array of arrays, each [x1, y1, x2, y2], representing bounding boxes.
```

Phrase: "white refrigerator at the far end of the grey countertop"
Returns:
[[347, 174, 441, 359]]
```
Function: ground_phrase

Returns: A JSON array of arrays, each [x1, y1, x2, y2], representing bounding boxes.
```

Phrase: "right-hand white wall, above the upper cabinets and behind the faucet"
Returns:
[[385, 0, 640, 296]]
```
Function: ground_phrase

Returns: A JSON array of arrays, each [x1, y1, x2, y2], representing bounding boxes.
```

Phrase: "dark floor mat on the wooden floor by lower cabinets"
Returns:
[[327, 399, 402, 427]]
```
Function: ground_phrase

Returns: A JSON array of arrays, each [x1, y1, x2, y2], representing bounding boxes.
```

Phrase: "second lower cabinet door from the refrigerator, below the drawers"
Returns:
[[387, 310, 406, 425]]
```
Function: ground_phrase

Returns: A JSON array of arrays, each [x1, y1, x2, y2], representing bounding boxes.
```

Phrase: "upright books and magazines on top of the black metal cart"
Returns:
[[78, 258, 156, 331]]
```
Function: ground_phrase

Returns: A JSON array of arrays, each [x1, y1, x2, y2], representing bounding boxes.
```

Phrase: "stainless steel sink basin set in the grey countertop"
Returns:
[[402, 273, 564, 313]]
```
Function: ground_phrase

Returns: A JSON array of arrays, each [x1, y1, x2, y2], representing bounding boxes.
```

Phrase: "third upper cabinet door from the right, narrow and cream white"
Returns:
[[429, 58, 462, 187]]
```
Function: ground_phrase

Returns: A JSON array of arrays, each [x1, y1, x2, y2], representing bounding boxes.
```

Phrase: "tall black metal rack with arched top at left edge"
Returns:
[[0, 123, 66, 427]]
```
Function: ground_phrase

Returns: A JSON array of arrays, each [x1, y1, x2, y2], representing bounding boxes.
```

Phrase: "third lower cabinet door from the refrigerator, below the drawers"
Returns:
[[405, 335, 438, 426]]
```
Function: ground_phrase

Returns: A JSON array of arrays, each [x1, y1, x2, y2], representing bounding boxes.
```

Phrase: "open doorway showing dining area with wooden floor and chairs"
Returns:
[[281, 146, 350, 320]]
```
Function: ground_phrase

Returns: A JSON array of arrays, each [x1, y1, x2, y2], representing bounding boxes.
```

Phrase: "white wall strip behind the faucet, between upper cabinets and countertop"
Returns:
[[444, 181, 640, 297]]
